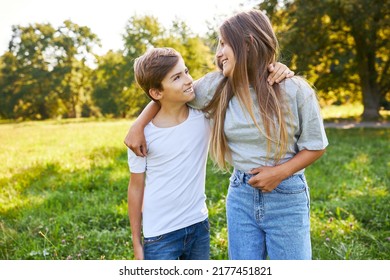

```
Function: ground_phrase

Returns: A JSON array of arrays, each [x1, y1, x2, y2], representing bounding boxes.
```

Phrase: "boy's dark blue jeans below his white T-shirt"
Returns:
[[144, 219, 210, 260]]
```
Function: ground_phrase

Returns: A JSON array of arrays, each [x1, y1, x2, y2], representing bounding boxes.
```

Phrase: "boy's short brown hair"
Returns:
[[134, 48, 181, 101]]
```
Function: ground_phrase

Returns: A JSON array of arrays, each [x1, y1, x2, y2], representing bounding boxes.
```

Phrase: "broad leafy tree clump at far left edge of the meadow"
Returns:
[[0, 21, 99, 119]]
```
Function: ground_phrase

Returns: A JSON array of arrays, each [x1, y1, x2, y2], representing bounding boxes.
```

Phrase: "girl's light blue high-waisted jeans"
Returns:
[[226, 170, 311, 260]]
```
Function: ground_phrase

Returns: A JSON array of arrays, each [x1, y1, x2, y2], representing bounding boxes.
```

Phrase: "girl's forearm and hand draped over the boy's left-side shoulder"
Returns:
[[124, 101, 160, 157]]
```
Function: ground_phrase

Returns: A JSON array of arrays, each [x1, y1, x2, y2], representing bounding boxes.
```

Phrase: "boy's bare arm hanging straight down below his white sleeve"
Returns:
[[127, 173, 145, 260]]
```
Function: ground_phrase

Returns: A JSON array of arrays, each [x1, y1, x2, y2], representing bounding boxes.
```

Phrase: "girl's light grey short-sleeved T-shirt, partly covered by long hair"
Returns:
[[190, 72, 328, 174]]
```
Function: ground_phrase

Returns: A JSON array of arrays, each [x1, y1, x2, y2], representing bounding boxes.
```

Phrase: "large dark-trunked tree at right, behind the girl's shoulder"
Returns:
[[258, 0, 390, 120]]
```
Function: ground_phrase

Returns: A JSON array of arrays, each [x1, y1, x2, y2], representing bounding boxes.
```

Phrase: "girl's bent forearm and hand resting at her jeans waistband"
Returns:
[[248, 149, 325, 192]]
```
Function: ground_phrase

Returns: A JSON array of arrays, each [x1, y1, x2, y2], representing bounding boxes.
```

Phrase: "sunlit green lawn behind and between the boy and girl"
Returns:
[[0, 120, 390, 260]]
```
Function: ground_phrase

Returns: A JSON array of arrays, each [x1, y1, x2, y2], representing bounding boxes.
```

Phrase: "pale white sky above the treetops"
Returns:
[[0, 0, 259, 55]]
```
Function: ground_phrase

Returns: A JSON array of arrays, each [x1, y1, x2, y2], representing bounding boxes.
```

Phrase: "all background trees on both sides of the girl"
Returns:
[[0, 0, 390, 120]]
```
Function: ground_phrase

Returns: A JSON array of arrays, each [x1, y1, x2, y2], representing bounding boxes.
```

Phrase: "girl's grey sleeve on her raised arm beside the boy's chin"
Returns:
[[188, 72, 223, 110]]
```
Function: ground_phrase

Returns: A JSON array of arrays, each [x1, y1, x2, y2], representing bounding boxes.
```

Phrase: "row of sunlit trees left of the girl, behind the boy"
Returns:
[[0, 16, 214, 120]]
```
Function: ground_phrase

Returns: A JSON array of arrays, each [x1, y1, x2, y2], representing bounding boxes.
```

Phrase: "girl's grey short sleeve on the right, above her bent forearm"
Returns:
[[297, 81, 328, 151]]
